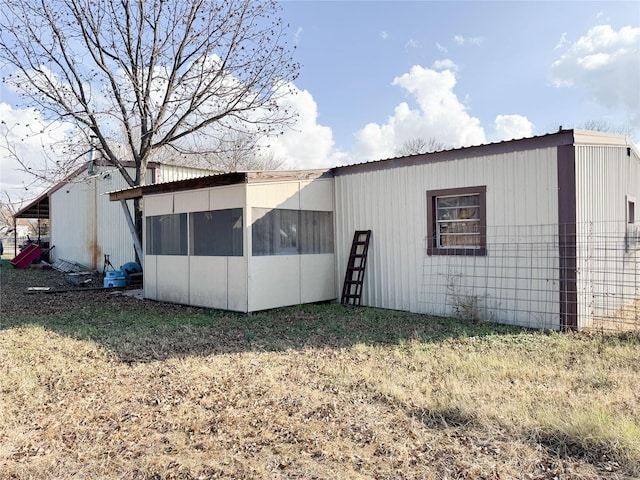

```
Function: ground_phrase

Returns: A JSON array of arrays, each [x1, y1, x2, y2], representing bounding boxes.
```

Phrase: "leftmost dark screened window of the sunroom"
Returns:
[[146, 213, 187, 255]]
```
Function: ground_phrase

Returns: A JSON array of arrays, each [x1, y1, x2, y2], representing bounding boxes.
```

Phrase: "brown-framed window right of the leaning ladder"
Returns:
[[427, 186, 487, 255]]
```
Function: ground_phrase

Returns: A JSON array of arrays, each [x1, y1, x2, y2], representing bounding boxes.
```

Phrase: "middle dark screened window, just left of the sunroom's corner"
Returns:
[[189, 208, 243, 257]]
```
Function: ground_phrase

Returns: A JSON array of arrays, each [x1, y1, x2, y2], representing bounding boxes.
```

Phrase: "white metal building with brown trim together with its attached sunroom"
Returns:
[[91, 130, 640, 330]]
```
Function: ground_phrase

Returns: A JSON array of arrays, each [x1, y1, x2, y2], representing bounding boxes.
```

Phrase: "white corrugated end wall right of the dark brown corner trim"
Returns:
[[576, 145, 640, 328]]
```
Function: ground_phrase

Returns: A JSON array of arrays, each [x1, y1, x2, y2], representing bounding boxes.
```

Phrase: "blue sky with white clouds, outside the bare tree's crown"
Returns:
[[0, 0, 640, 198]]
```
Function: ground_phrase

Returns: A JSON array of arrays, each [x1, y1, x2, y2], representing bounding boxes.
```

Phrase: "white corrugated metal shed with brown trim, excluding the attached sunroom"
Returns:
[[333, 130, 640, 330]]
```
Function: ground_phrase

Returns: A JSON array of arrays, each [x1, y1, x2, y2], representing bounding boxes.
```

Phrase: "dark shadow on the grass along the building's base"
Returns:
[[0, 262, 523, 362]]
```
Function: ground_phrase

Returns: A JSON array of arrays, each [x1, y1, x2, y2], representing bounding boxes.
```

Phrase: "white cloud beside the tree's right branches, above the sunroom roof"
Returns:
[[263, 85, 345, 169]]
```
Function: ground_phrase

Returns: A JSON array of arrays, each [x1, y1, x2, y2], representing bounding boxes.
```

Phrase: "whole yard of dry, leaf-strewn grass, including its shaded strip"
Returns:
[[0, 261, 640, 480]]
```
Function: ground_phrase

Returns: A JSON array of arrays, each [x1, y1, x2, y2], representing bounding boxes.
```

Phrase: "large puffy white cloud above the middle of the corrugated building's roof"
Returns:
[[354, 65, 485, 161]]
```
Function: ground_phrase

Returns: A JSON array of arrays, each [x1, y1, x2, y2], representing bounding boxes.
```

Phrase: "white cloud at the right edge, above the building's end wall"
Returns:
[[551, 25, 640, 134]]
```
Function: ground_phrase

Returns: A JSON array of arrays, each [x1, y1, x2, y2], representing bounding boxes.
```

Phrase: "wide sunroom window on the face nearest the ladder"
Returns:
[[251, 208, 333, 256]]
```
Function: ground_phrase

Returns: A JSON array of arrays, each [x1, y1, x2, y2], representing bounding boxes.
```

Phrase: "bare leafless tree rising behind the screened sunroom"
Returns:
[[0, 0, 298, 242]]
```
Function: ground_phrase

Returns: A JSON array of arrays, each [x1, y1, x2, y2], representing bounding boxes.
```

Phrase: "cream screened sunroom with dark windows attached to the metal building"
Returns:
[[111, 170, 336, 312]]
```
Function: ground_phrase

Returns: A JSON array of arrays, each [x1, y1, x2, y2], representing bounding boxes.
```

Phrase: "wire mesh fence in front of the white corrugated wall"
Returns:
[[421, 222, 640, 331]]
